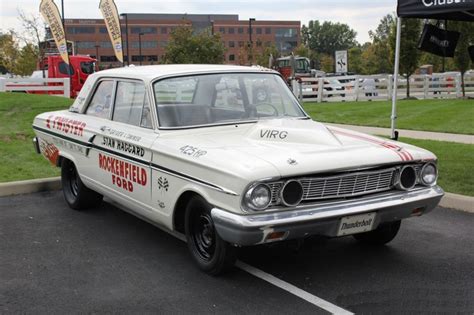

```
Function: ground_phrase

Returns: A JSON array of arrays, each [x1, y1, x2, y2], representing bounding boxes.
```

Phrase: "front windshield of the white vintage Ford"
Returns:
[[153, 73, 306, 128]]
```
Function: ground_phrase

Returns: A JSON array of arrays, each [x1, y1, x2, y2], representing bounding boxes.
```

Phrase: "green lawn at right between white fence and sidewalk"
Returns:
[[304, 100, 474, 134]]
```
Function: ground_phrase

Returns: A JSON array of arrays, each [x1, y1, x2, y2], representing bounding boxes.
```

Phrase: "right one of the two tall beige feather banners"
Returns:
[[99, 0, 123, 63]]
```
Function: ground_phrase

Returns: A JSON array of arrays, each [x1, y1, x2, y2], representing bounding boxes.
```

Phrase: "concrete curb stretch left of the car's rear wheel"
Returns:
[[0, 177, 61, 197]]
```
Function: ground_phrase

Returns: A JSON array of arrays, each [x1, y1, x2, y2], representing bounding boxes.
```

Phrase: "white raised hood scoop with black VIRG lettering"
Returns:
[[246, 119, 342, 146]]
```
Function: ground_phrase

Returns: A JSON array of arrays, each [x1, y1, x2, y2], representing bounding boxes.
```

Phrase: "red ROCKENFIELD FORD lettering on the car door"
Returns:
[[99, 153, 147, 192]]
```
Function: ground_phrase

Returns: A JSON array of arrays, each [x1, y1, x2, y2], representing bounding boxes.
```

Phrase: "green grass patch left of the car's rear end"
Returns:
[[0, 93, 73, 182]]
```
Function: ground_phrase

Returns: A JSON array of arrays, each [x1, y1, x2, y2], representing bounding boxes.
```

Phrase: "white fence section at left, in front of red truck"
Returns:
[[0, 78, 71, 98]]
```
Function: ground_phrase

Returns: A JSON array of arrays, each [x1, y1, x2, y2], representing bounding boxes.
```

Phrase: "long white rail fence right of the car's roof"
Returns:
[[292, 73, 474, 102]]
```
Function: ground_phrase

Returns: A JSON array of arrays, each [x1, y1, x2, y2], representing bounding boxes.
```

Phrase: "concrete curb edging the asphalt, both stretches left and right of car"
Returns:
[[0, 177, 474, 213]]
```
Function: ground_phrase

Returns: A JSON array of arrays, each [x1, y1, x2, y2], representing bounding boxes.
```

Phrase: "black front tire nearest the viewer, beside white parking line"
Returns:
[[185, 196, 237, 276]]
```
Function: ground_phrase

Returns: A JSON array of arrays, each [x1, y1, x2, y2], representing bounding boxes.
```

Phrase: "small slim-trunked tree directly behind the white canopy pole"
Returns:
[[389, 19, 421, 98]]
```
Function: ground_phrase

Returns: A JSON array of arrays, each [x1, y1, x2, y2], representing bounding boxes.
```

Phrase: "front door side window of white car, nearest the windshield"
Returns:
[[112, 82, 151, 128]]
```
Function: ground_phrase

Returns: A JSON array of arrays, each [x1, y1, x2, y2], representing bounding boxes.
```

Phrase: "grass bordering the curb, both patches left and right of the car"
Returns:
[[0, 93, 474, 196]]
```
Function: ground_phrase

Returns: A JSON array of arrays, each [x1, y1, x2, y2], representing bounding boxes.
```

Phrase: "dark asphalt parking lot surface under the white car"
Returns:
[[0, 192, 474, 314]]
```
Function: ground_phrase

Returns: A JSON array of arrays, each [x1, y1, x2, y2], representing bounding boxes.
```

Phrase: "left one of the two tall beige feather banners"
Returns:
[[40, 0, 69, 64]]
